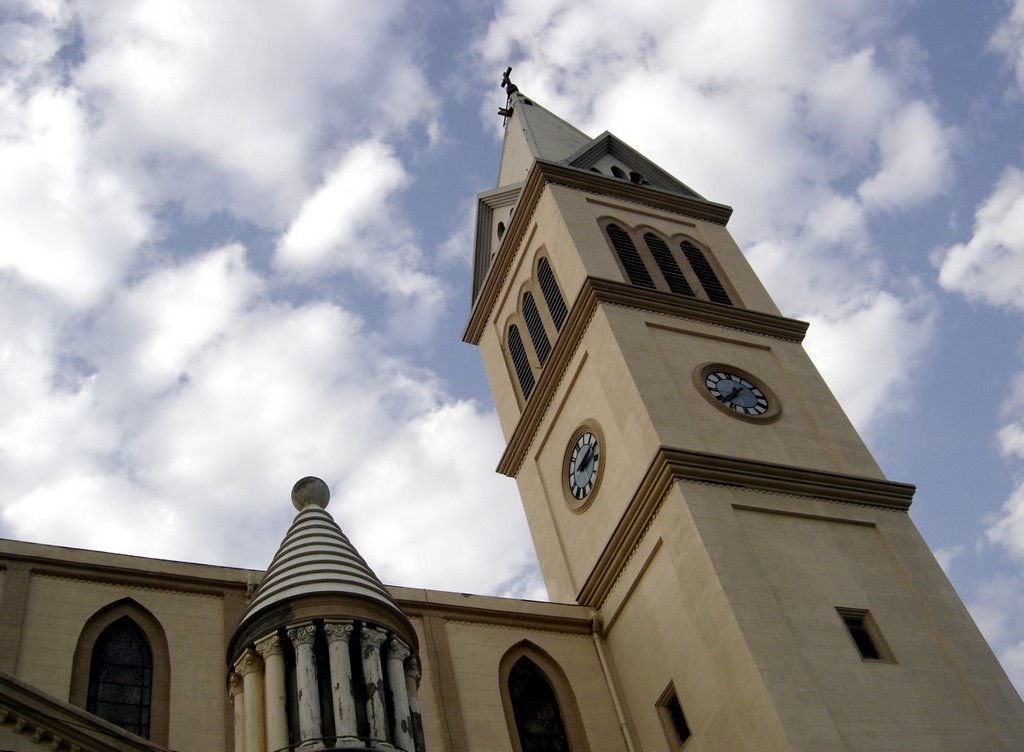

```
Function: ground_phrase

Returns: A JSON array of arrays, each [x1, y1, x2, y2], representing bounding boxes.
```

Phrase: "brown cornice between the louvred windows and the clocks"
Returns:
[[498, 277, 807, 477]]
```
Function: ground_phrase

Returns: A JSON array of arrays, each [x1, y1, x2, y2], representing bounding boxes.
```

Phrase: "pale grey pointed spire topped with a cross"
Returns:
[[498, 68, 592, 187]]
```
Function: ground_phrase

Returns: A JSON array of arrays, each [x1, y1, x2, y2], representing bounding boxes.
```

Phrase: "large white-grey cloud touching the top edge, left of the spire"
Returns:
[[75, 0, 435, 226]]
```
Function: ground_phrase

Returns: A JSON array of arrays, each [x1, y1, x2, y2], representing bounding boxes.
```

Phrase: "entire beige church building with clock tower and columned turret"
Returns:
[[0, 85, 1024, 752]]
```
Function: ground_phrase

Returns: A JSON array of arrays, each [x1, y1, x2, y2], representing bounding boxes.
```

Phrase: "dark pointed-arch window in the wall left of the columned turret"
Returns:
[[86, 617, 153, 739]]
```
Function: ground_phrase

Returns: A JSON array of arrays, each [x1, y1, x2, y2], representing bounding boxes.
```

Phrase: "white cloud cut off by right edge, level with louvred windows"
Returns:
[[939, 167, 1024, 309]]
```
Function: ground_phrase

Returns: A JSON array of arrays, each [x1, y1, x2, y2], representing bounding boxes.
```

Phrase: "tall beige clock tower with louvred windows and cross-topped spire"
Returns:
[[464, 75, 1024, 752]]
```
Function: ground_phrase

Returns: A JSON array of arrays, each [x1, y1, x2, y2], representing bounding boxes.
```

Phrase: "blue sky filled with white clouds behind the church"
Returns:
[[0, 0, 1024, 688]]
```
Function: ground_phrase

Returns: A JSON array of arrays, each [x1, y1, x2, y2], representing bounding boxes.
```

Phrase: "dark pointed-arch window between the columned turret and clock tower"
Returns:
[[509, 656, 569, 752]]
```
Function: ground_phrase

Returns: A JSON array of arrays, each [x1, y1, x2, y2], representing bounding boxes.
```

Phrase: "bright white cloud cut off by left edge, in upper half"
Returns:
[[0, 86, 151, 306]]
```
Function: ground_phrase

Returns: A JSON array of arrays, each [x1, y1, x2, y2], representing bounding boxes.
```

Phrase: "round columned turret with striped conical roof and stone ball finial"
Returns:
[[227, 477, 424, 752]]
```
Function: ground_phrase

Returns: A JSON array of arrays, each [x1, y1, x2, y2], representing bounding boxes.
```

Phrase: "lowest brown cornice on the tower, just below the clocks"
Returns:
[[577, 447, 914, 609]]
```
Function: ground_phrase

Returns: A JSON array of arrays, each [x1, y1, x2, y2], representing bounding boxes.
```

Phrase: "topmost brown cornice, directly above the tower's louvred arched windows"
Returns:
[[462, 160, 732, 344]]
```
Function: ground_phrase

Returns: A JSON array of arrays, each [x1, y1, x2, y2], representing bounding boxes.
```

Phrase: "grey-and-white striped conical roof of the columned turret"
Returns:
[[242, 478, 401, 624]]
